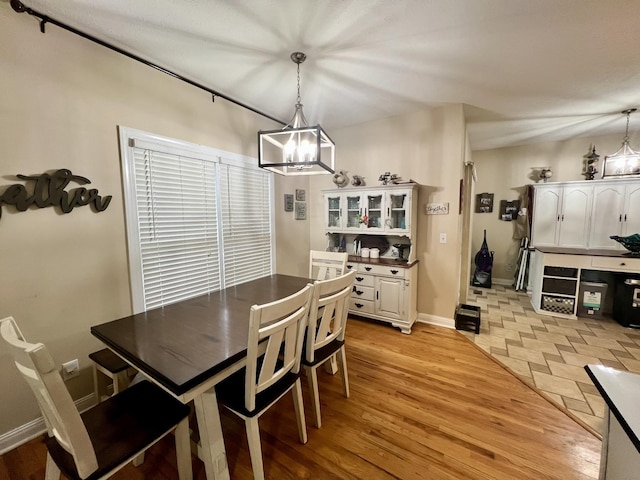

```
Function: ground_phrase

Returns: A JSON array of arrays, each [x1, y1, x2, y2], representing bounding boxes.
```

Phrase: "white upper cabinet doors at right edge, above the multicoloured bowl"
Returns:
[[589, 181, 640, 250]]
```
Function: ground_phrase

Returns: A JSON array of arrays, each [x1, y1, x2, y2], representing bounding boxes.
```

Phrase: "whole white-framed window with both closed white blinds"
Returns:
[[120, 127, 274, 313]]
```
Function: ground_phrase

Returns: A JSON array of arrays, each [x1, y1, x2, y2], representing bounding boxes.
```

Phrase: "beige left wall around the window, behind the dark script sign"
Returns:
[[0, 2, 309, 435]]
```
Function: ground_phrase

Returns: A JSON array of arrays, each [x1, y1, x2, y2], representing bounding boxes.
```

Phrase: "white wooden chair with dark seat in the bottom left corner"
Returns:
[[0, 317, 193, 480]]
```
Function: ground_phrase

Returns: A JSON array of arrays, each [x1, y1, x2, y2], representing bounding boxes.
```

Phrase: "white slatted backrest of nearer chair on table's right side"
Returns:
[[245, 284, 313, 410]]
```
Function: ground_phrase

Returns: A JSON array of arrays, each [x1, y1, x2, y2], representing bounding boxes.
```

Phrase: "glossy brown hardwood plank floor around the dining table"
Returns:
[[0, 319, 601, 480]]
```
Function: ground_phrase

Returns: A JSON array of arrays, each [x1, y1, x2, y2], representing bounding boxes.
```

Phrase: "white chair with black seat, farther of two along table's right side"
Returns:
[[302, 271, 356, 428]]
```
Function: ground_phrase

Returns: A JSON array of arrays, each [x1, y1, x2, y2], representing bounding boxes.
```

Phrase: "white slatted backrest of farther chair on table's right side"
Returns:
[[306, 271, 356, 362]]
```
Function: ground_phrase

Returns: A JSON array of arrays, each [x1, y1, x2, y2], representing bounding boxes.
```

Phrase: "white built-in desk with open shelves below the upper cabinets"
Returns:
[[530, 247, 640, 328]]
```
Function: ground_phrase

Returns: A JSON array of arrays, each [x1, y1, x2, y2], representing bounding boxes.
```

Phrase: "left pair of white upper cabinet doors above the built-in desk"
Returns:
[[532, 182, 593, 248]]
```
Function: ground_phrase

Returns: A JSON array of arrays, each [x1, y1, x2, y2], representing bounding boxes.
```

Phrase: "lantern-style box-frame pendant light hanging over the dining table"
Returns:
[[258, 52, 336, 175]]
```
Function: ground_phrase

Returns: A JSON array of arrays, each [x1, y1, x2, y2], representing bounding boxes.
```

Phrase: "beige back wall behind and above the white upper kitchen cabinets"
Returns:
[[471, 131, 640, 281]]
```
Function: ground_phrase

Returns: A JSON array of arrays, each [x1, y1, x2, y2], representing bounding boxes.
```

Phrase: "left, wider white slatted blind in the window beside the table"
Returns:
[[134, 148, 220, 310]]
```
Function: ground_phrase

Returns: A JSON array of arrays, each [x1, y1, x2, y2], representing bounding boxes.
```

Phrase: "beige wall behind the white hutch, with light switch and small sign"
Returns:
[[310, 105, 465, 318]]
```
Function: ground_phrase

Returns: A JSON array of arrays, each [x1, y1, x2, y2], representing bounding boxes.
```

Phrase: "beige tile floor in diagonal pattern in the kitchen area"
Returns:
[[461, 285, 640, 432]]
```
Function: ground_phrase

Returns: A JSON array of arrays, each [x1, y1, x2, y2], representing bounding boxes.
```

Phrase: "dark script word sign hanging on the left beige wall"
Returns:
[[0, 168, 111, 218]]
